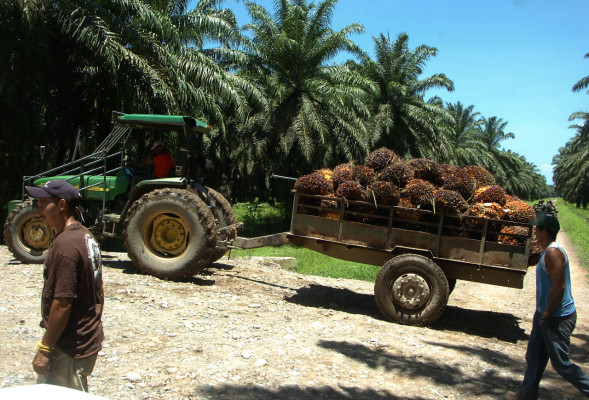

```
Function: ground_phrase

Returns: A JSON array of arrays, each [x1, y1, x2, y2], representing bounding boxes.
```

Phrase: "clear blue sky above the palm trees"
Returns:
[[224, 0, 589, 184]]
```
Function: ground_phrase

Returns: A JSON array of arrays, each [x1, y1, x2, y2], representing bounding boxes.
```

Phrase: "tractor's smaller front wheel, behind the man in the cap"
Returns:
[[4, 201, 53, 264]]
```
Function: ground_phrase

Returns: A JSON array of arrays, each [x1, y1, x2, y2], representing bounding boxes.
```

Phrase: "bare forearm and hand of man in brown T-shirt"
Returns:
[[33, 298, 73, 375]]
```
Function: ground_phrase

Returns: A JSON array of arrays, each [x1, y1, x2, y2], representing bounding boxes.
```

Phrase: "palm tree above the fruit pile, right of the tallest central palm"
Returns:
[[350, 33, 454, 157]]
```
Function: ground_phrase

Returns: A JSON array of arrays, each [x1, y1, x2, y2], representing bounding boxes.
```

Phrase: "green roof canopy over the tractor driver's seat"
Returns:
[[112, 111, 211, 134]]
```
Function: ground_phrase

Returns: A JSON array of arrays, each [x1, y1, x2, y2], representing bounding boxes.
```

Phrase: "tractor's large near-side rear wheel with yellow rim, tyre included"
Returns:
[[124, 188, 217, 279]]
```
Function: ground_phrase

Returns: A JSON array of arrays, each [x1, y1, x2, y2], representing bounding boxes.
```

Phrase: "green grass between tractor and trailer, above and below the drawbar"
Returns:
[[231, 202, 380, 282]]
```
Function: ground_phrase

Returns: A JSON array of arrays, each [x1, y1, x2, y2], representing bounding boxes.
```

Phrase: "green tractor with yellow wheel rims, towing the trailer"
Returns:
[[4, 112, 236, 279]]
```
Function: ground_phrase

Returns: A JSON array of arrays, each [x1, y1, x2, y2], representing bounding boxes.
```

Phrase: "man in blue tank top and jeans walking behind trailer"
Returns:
[[507, 215, 589, 400]]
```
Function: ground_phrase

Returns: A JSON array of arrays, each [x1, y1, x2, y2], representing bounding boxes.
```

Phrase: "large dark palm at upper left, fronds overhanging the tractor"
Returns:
[[0, 0, 262, 212]]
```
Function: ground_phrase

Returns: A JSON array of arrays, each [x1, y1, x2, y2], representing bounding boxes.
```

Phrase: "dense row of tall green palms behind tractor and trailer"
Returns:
[[0, 0, 568, 222]]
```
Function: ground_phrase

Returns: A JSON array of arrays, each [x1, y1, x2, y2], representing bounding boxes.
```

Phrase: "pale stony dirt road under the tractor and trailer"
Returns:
[[0, 234, 589, 400]]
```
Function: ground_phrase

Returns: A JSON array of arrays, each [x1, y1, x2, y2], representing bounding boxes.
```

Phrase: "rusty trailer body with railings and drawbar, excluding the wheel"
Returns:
[[235, 192, 532, 289]]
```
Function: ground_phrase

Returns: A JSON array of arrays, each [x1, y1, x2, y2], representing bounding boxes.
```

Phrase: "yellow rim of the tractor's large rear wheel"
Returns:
[[149, 213, 190, 256]]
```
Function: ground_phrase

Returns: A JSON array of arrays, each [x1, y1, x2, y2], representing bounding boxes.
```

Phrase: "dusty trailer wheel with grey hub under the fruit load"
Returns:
[[374, 254, 449, 325]]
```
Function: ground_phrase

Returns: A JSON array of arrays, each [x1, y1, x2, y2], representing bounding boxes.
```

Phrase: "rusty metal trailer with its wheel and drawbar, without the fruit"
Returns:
[[235, 192, 532, 325]]
